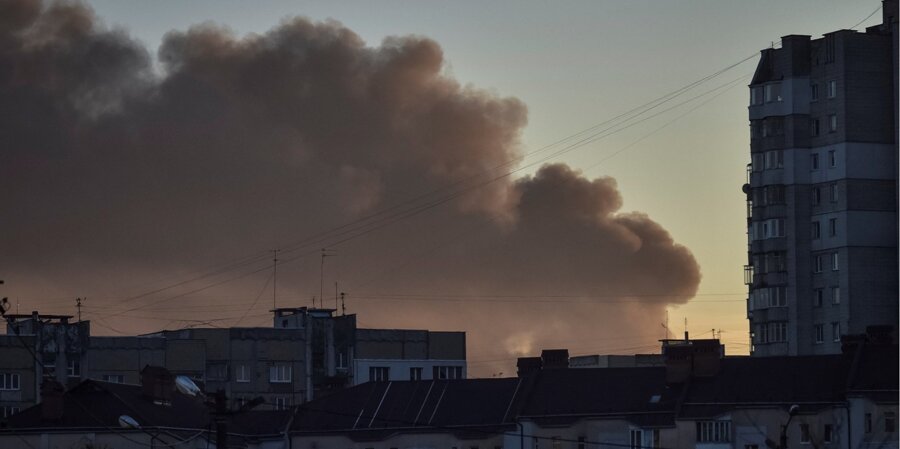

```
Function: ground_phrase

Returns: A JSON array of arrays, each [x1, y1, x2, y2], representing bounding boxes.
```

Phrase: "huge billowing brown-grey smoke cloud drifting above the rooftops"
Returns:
[[0, 0, 700, 374]]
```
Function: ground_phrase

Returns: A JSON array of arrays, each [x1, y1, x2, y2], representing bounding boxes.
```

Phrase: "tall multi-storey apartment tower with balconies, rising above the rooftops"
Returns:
[[744, 0, 898, 356]]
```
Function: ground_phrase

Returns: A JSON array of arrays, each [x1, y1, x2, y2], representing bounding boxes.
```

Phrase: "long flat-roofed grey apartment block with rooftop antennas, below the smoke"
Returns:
[[0, 307, 466, 412]]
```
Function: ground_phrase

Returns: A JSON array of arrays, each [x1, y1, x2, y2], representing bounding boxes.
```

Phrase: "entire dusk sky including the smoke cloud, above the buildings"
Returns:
[[0, 0, 880, 376]]
